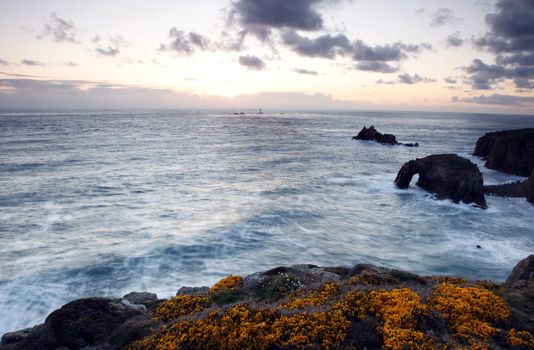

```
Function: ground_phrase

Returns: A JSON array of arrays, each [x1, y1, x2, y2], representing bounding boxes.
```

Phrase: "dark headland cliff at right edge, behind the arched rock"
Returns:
[[473, 129, 534, 176]]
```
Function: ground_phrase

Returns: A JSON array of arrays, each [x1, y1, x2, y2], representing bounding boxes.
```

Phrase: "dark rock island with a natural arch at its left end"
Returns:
[[395, 154, 486, 208]]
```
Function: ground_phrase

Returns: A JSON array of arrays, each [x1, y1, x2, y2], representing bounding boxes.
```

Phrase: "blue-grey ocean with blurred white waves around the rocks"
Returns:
[[0, 110, 534, 334]]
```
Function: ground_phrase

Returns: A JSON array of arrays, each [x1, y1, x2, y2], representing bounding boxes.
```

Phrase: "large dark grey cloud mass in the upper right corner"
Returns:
[[464, 0, 534, 89]]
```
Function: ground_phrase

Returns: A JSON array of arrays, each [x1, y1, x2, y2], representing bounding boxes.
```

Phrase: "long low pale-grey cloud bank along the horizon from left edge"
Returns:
[[0, 79, 357, 110]]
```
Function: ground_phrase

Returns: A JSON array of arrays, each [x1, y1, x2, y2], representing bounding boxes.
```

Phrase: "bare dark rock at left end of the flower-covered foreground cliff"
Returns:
[[0, 293, 157, 350]]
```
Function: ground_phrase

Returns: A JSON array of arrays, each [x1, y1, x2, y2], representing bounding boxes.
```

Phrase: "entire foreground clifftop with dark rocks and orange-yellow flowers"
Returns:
[[0, 255, 534, 350]]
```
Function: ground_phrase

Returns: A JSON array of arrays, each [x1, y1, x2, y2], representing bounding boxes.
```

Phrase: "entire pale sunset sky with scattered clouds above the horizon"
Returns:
[[0, 0, 534, 114]]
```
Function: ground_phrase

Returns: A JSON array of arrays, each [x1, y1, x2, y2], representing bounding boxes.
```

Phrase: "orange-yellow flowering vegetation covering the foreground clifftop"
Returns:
[[130, 268, 534, 350]]
